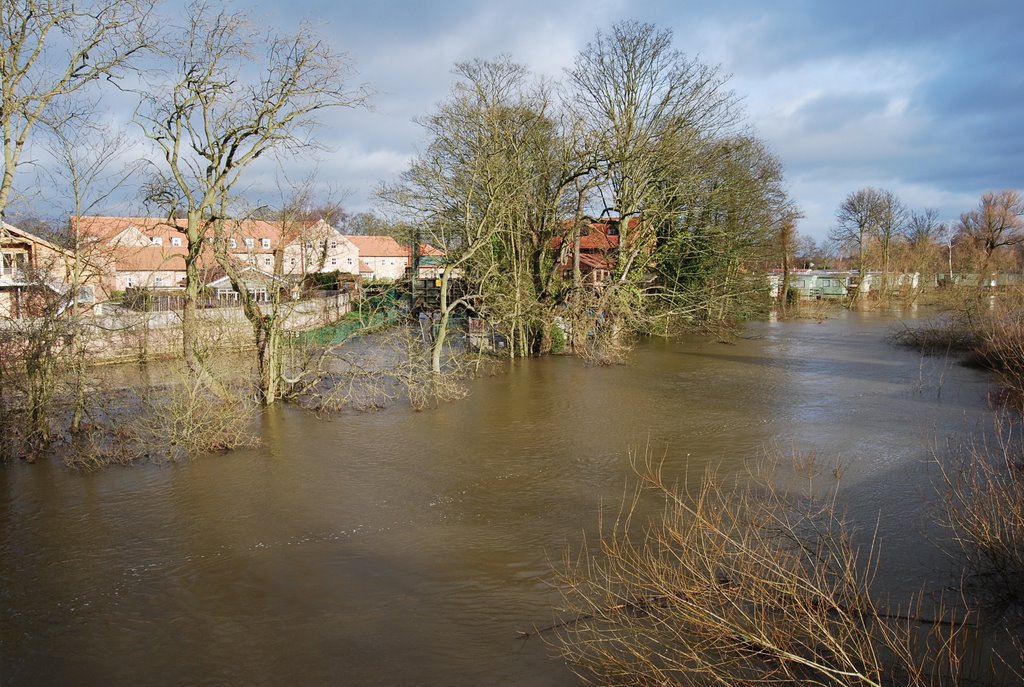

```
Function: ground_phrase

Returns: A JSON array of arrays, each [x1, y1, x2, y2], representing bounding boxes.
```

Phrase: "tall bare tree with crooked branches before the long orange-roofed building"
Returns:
[[135, 3, 367, 393]]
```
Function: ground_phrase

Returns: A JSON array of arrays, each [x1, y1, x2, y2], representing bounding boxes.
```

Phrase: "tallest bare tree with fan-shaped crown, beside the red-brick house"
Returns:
[[568, 22, 738, 282]]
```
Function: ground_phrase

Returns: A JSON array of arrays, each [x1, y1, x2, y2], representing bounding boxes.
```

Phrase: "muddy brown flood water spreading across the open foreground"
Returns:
[[0, 312, 989, 686]]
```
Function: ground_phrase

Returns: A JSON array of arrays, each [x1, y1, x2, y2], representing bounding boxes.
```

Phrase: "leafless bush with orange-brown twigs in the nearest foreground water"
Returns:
[[553, 450, 964, 686]]
